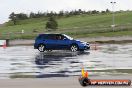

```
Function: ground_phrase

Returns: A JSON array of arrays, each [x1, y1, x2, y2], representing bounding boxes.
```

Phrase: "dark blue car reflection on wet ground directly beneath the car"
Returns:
[[35, 51, 90, 67]]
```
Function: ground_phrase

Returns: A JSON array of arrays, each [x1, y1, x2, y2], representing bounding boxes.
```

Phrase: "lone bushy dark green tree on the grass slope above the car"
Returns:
[[46, 16, 58, 30]]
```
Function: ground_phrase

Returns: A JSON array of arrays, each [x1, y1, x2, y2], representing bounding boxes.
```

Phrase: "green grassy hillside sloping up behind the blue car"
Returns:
[[0, 11, 132, 39]]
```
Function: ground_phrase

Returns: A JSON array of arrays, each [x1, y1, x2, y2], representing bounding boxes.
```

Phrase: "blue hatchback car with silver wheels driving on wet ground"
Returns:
[[34, 34, 90, 52]]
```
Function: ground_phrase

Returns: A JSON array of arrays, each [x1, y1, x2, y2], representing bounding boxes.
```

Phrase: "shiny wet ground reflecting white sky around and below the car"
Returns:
[[0, 43, 132, 78]]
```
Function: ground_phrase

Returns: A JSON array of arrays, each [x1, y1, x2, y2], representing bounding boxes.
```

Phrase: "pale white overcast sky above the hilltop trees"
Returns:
[[0, 0, 132, 23]]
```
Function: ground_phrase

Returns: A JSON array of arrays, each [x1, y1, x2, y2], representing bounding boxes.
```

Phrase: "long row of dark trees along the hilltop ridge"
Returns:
[[9, 9, 110, 20]]
